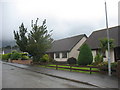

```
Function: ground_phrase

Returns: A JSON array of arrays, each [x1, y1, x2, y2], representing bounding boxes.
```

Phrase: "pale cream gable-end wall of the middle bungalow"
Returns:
[[68, 37, 87, 59]]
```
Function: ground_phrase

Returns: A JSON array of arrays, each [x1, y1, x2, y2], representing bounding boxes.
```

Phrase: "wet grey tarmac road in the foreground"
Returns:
[[2, 64, 95, 90]]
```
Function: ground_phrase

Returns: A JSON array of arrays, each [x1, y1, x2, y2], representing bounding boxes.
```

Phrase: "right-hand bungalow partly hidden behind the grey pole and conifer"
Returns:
[[85, 26, 120, 62]]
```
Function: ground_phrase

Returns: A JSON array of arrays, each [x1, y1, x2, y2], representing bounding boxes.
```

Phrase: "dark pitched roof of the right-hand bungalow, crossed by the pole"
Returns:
[[85, 26, 120, 49]]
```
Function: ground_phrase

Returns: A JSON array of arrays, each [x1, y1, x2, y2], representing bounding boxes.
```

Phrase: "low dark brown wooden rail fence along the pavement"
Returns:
[[39, 64, 117, 76]]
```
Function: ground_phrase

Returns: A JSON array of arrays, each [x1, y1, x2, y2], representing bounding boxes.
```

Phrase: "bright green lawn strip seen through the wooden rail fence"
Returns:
[[37, 64, 99, 73]]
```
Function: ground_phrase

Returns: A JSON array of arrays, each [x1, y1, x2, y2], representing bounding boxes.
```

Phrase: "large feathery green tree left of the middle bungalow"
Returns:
[[14, 18, 53, 62]]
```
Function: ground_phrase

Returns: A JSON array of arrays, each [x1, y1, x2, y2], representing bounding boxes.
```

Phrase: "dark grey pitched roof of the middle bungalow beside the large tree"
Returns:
[[47, 34, 87, 53]]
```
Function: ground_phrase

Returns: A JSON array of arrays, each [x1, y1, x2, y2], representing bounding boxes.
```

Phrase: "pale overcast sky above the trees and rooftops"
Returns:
[[0, 0, 119, 40]]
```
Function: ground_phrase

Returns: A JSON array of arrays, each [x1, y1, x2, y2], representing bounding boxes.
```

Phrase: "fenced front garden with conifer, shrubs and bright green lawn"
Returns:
[[36, 44, 117, 74]]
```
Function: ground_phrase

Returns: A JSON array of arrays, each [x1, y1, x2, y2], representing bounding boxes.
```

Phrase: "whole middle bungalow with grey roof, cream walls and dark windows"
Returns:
[[47, 34, 87, 61]]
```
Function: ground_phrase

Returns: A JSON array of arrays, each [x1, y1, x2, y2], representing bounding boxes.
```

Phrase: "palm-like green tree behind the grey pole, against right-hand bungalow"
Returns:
[[100, 38, 114, 55]]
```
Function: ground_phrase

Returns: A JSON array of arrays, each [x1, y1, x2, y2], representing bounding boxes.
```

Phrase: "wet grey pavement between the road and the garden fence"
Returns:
[[3, 63, 118, 88]]
